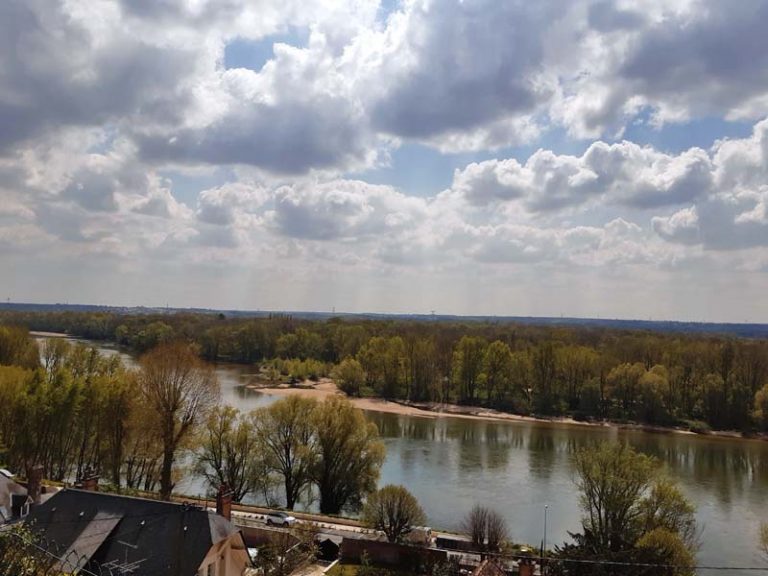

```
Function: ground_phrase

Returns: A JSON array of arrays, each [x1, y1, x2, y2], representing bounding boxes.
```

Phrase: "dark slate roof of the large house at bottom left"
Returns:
[[27, 489, 238, 576]]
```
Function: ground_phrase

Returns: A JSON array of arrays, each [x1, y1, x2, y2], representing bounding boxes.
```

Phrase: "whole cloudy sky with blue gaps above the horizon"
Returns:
[[0, 0, 768, 322]]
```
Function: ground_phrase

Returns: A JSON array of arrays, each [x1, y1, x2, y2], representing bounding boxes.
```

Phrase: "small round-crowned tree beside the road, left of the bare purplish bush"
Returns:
[[361, 484, 426, 542]]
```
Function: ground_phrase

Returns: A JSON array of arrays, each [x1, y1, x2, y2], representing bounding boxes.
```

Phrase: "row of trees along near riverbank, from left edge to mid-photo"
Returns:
[[0, 326, 385, 514]]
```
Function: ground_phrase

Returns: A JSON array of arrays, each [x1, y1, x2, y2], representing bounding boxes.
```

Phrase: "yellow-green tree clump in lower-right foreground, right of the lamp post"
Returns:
[[552, 443, 697, 576]]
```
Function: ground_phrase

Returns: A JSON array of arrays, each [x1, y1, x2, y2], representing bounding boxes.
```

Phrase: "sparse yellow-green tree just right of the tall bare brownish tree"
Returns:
[[198, 406, 261, 502]]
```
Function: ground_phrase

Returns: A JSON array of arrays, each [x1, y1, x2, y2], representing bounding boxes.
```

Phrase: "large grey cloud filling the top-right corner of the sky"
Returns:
[[552, 0, 768, 137]]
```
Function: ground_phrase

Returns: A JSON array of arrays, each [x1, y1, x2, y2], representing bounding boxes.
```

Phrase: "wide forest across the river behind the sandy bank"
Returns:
[[0, 312, 768, 431]]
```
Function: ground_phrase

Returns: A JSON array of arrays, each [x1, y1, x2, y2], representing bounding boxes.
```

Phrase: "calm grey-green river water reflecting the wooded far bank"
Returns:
[[43, 338, 768, 574]]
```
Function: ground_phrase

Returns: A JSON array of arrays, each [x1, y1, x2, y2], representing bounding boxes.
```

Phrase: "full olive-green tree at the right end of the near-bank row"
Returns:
[[312, 396, 386, 514]]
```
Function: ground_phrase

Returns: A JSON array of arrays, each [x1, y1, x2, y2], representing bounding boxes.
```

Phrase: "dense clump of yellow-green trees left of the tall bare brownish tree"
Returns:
[[0, 326, 149, 490]]
